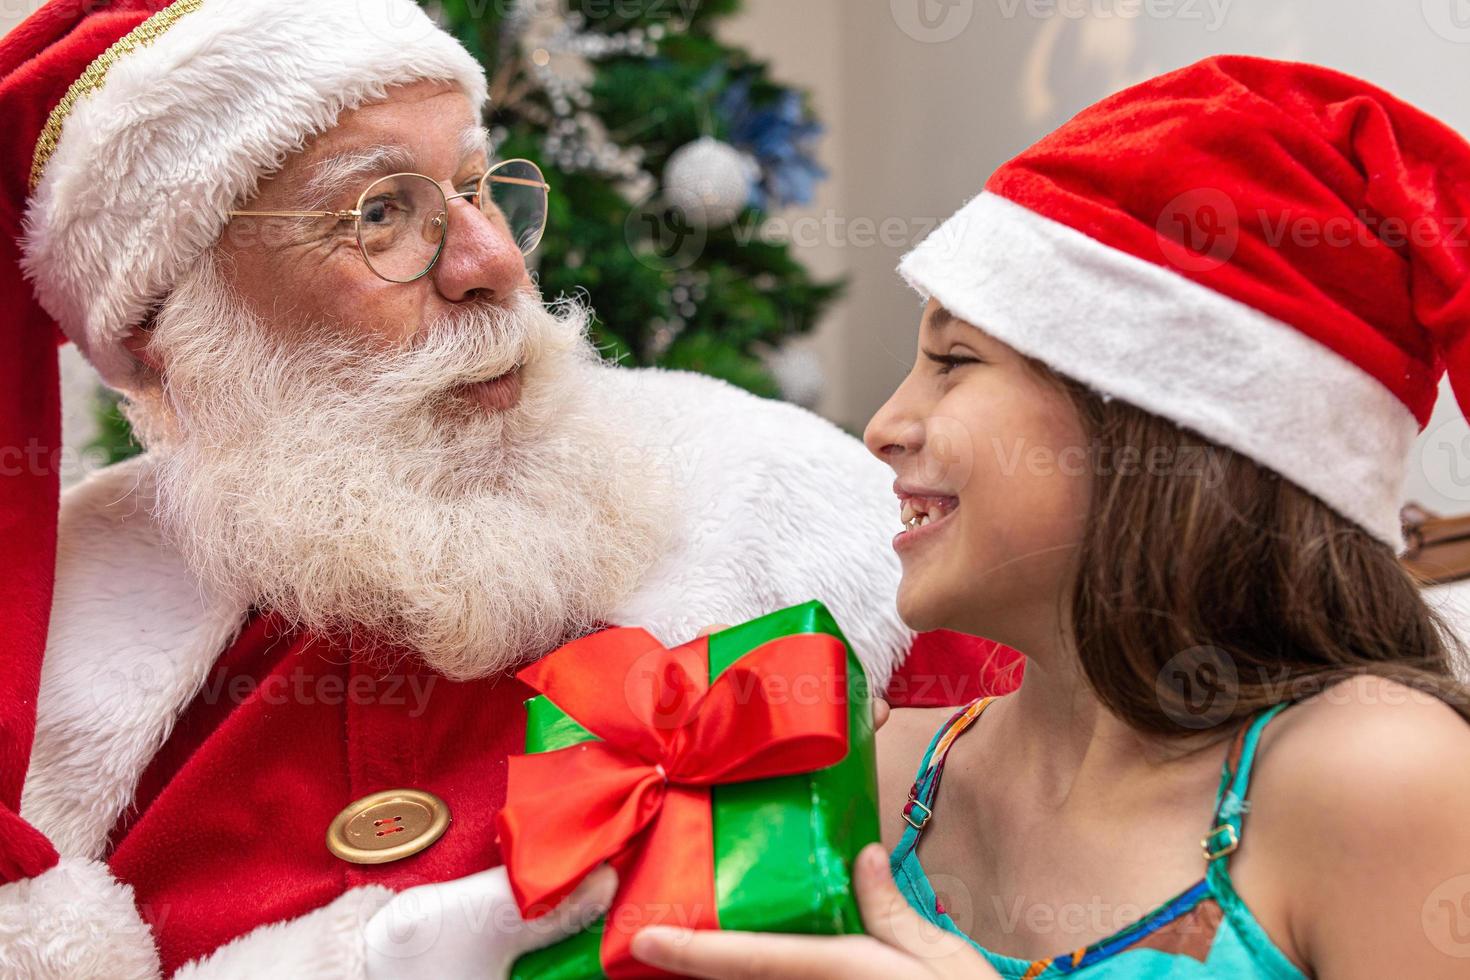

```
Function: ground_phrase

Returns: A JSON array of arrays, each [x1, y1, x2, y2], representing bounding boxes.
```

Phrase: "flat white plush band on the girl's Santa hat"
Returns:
[[898, 192, 1419, 551]]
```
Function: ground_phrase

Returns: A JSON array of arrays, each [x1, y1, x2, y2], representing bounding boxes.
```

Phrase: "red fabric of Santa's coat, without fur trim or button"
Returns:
[[107, 616, 1007, 973]]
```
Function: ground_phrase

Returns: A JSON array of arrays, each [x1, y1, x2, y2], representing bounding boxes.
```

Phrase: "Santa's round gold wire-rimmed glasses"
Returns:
[[229, 159, 551, 282]]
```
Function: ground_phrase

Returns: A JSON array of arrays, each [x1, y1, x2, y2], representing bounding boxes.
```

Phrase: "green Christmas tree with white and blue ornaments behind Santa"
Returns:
[[96, 0, 839, 460]]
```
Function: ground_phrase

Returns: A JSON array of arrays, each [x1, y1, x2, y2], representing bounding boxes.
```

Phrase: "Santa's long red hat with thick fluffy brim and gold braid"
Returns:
[[0, 0, 485, 883]]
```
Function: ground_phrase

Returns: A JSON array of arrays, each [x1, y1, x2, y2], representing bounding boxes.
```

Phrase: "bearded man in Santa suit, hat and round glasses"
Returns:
[[0, 0, 1013, 977]]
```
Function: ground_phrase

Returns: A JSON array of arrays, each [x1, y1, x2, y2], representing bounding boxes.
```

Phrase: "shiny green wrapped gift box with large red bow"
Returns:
[[497, 602, 879, 980]]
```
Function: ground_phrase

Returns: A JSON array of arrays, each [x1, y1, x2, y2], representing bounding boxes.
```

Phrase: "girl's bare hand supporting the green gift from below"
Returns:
[[632, 843, 1000, 980]]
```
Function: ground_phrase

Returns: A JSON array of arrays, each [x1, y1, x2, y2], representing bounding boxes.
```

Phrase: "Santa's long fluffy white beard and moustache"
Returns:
[[128, 257, 670, 679]]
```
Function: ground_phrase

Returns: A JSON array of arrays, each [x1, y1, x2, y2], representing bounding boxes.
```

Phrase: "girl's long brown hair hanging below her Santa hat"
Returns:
[[1032, 361, 1470, 736]]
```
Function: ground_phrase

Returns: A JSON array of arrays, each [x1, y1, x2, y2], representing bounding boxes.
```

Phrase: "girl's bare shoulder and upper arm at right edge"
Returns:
[[1232, 676, 1470, 976]]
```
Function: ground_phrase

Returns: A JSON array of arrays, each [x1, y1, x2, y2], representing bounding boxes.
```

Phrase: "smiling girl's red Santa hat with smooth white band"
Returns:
[[900, 57, 1470, 550]]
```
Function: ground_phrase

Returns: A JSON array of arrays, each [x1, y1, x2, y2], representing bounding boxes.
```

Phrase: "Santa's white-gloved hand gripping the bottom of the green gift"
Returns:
[[366, 865, 617, 980]]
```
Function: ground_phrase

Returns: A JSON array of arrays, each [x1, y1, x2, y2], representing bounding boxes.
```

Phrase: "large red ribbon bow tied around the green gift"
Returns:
[[497, 629, 847, 977]]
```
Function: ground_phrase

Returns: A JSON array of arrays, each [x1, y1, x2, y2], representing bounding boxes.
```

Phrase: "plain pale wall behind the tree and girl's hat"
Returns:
[[0, 0, 1470, 513]]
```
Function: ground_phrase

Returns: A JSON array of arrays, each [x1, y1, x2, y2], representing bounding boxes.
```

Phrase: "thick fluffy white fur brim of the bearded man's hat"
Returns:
[[22, 0, 487, 381]]
